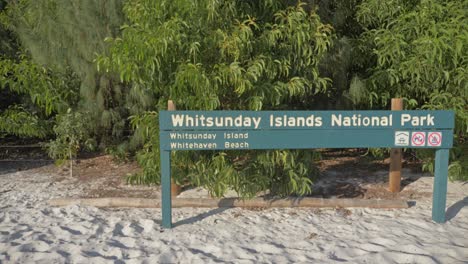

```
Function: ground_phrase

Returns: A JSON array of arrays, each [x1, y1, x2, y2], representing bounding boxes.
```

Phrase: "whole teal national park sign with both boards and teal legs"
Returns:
[[159, 111, 454, 228]]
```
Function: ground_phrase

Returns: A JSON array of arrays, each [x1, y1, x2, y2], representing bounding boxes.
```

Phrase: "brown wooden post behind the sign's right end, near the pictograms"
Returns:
[[388, 98, 403, 193]]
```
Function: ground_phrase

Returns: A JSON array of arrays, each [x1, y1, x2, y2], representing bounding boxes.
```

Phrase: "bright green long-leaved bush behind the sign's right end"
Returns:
[[349, 0, 468, 178]]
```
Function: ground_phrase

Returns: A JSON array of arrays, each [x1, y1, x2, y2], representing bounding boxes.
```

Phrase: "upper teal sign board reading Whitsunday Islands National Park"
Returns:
[[159, 111, 454, 130]]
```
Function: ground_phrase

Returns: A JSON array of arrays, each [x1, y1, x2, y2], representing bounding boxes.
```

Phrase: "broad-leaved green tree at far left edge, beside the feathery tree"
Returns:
[[0, 1, 77, 138]]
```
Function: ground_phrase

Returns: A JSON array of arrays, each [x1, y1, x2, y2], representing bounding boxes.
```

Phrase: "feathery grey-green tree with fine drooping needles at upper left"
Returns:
[[1, 0, 127, 142]]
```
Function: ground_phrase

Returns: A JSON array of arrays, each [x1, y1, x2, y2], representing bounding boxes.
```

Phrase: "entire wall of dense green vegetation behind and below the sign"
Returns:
[[0, 0, 468, 196]]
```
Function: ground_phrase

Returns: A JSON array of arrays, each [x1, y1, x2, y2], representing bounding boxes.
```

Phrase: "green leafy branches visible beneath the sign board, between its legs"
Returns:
[[181, 150, 317, 197]]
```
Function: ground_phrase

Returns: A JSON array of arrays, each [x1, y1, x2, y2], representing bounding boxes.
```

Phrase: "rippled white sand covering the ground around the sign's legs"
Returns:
[[0, 166, 468, 264]]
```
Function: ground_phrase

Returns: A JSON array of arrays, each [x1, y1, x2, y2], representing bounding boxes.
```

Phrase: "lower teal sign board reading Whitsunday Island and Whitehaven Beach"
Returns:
[[160, 130, 453, 150]]
